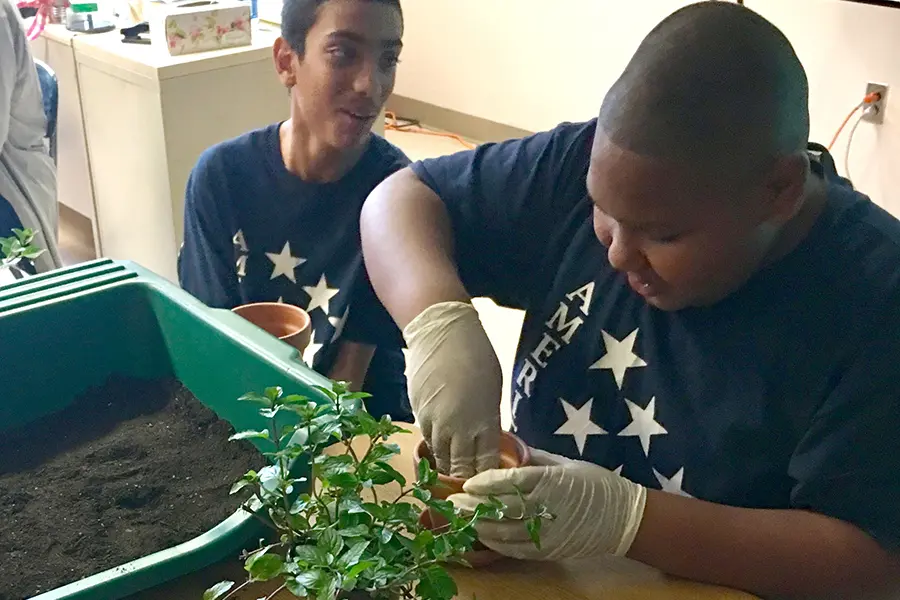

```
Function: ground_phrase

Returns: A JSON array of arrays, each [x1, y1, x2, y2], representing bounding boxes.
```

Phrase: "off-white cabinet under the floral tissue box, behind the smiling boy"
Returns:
[[73, 25, 289, 281]]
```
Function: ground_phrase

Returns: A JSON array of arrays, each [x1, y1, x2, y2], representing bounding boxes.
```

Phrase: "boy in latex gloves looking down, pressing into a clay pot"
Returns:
[[361, 2, 900, 598]]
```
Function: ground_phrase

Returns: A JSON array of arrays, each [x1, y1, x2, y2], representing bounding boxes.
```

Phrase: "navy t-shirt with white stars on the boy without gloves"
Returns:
[[178, 125, 412, 420]]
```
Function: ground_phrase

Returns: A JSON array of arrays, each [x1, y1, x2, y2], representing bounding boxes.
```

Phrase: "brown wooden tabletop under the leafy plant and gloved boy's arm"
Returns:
[[136, 426, 755, 600]]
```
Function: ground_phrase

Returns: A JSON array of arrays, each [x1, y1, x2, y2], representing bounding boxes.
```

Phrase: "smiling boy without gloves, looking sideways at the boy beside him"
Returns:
[[178, 0, 411, 420]]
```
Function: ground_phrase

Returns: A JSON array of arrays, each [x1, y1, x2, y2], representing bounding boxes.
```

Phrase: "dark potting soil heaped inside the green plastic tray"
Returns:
[[0, 377, 265, 600]]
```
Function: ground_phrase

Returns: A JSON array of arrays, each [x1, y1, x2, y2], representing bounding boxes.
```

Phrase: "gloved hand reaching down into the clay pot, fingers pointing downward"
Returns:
[[403, 302, 503, 477]]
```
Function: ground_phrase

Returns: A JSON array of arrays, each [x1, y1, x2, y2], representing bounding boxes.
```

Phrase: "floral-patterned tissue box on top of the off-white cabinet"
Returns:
[[150, 1, 252, 56]]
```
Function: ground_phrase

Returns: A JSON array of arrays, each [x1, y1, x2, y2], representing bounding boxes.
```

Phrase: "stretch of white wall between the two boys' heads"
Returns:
[[395, 0, 690, 131]]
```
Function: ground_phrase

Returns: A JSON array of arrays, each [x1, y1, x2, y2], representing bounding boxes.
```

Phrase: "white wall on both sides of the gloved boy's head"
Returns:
[[396, 0, 900, 215]]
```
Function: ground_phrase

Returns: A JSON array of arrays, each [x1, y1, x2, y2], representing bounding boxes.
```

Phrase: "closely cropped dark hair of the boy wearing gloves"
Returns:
[[599, 1, 809, 171]]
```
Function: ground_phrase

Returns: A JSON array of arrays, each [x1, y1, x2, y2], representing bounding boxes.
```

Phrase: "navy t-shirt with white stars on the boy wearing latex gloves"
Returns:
[[412, 121, 900, 550]]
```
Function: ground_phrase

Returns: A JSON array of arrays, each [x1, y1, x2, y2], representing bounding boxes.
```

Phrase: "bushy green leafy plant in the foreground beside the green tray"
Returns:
[[203, 383, 549, 600]]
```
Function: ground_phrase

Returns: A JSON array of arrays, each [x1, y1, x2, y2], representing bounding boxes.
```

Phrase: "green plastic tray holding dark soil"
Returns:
[[0, 260, 328, 600]]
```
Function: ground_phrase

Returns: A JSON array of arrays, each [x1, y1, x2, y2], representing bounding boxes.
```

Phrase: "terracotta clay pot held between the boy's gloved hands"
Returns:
[[413, 431, 531, 567]]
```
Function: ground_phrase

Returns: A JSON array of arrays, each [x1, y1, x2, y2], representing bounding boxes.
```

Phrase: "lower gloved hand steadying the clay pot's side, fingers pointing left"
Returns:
[[449, 450, 647, 560]]
